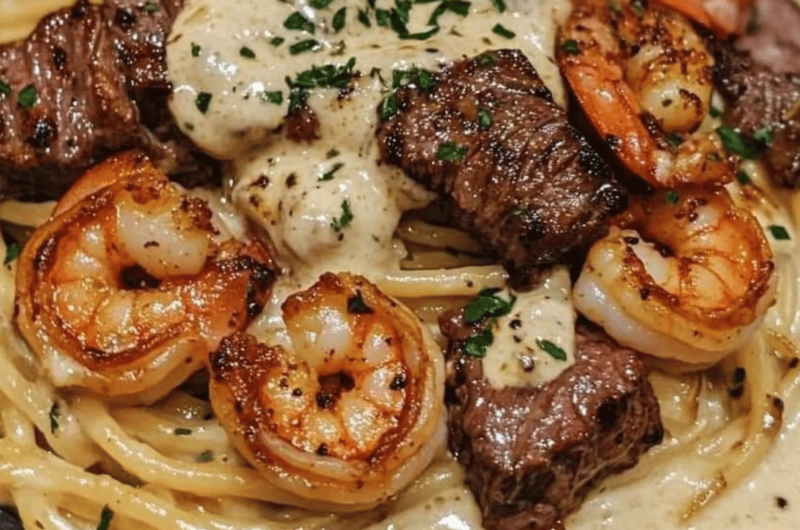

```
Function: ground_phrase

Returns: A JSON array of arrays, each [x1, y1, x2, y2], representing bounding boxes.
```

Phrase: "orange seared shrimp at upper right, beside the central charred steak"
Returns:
[[558, 0, 735, 187]]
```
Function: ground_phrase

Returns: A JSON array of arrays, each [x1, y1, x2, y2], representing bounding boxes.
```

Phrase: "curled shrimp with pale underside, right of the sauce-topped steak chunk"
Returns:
[[574, 186, 776, 370]]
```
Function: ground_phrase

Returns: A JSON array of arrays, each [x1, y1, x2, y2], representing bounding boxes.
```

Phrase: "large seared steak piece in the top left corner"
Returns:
[[0, 0, 210, 197]]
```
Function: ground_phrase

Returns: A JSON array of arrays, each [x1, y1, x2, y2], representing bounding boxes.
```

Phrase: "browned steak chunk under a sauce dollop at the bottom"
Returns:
[[441, 317, 663, 530]]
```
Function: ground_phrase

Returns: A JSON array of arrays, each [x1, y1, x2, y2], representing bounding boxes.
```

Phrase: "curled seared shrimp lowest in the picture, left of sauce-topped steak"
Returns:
[[210, 273, 446, 511]]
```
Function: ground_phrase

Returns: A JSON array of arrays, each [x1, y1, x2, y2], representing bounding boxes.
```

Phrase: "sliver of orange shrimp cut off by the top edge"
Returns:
[[657, 0, 756, 38]]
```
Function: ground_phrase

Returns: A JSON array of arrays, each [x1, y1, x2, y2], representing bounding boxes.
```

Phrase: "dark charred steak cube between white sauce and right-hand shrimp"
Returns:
[[378, 50, 626, 275]]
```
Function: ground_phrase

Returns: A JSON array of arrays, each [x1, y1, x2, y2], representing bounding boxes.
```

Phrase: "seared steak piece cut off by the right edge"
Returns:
[[715, 0, 800, 189]]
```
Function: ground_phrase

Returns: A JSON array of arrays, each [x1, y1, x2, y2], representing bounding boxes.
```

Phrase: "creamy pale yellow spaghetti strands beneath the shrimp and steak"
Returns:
[[0, 0, 800, 530]]
